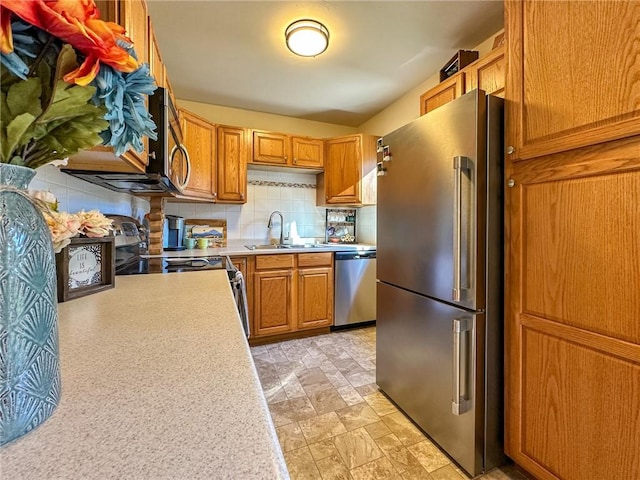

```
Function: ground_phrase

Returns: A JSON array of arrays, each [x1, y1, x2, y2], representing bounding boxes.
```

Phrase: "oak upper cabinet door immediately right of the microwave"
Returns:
[[180, 109, 216, 199]]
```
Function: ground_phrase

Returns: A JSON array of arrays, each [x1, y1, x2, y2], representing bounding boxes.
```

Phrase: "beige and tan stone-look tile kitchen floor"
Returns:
[[251, 327, 529, 480]]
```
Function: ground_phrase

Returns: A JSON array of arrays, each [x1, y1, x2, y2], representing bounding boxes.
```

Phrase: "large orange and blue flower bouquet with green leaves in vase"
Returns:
[[0, 0, 156, 168]]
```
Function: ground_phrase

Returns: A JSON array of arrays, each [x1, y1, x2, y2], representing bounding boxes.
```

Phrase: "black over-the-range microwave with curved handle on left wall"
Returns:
[[62, 87, 191, 195]]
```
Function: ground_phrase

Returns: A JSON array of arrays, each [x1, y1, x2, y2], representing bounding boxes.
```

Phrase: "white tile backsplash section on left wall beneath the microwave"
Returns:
[[29, 165, 149, 220]]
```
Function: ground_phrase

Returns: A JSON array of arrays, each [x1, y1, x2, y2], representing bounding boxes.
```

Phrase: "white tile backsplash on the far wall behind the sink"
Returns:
[[165, 170, 375, 243]]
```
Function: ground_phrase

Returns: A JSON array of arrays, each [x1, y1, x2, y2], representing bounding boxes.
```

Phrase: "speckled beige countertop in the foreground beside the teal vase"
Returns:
[[0, 270, 289, 480]]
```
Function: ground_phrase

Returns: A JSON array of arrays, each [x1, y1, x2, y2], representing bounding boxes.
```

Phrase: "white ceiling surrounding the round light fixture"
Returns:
[[148, 0, 503, 127]]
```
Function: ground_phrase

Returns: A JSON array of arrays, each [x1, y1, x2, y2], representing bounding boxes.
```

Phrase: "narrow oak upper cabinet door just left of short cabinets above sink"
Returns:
[[217, 126, 247, 203]]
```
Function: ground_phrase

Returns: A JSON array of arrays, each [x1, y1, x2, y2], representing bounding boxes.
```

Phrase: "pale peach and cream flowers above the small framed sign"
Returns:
[[29, 190, 113, 253]]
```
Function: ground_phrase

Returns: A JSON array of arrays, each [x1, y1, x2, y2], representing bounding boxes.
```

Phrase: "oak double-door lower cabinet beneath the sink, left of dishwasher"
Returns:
[[249, 252, 333, 342]]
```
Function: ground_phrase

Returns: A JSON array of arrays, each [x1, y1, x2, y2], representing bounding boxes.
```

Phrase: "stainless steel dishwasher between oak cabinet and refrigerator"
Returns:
[[334, 250, 376, 327]]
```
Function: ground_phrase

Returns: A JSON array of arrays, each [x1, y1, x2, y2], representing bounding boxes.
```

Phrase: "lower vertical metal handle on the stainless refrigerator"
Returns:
[[451, 318, 473, 415]]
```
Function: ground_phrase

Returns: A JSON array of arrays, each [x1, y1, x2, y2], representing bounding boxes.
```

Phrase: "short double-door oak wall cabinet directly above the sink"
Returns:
[[250, 130, 324, 169]]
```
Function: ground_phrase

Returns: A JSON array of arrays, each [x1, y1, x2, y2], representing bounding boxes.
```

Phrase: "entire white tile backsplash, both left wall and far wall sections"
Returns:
[[29, 165, 376, 243]]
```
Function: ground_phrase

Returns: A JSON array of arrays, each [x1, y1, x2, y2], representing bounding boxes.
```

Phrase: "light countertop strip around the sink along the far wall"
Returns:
[[144, 240, 376, 258]]
